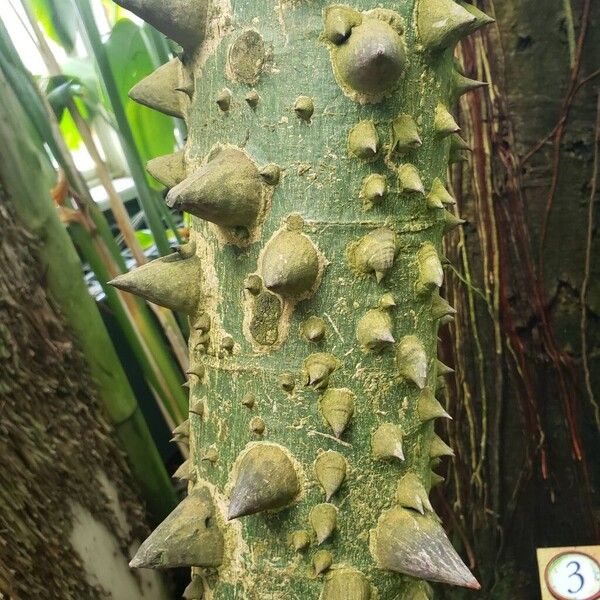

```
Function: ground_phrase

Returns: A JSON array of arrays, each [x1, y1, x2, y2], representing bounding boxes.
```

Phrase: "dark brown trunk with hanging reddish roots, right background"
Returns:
[[436, 0, 600, 599]]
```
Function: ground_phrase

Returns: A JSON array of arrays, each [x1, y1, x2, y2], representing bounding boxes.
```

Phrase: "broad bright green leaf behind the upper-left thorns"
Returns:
[[105, 19, 175, 189]]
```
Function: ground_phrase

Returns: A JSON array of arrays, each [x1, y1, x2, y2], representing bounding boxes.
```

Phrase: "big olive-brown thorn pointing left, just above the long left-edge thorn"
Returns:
[[167, 146, 265, 229]]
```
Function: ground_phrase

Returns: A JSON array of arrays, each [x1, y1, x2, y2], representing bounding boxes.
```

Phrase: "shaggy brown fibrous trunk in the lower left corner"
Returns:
[[0, 187, 145, 600]]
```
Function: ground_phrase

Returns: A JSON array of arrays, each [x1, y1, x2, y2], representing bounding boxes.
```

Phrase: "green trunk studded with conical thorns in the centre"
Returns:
[[115, 0, 490, 600]]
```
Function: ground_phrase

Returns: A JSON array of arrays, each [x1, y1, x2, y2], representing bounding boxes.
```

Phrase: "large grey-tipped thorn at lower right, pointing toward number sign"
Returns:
[[371, 508, 481, 590]]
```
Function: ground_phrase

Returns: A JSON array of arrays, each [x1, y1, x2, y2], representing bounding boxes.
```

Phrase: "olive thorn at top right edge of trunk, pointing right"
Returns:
[[417, 0, 489, 52]]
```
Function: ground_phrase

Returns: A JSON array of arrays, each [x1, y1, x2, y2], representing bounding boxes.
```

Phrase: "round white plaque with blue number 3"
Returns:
[[546, 552, 600, 600]]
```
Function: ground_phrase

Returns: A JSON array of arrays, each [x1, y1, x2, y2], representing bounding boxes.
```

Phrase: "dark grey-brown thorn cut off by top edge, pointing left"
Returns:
[[115, 0, 209, 49]]
